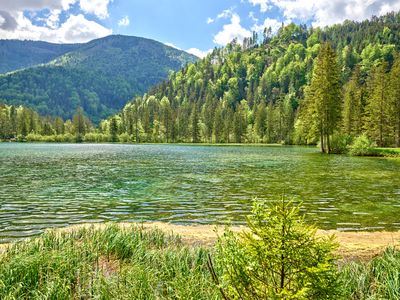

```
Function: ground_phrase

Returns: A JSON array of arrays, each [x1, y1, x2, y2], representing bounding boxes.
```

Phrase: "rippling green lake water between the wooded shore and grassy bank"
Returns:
[[0, 143, 400, 242]]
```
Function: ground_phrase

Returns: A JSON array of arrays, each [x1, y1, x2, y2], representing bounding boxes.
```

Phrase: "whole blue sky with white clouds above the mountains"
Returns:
[[0, 0, 400, 57]]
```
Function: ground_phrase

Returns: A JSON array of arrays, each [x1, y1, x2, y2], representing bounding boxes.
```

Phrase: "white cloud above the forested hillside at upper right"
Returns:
[[248, 0, 400, 27]]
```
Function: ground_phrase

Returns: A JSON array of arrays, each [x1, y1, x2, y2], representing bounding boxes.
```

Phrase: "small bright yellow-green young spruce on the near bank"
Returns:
[[217, 200, 340, 299]]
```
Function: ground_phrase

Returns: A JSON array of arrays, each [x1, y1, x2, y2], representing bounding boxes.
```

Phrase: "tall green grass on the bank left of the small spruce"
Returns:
[[0, 226, 219, 299]]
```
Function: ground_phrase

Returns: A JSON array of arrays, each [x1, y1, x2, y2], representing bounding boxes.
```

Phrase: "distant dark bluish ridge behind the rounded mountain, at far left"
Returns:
[[0, 40, 81, 73]]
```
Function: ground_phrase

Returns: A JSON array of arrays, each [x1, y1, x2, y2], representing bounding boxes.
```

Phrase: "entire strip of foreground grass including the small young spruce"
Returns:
[[0, 201, 400, 299]]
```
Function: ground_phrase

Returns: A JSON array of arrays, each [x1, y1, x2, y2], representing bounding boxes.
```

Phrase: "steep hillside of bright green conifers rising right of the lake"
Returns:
[[100, 13, 400, 151]]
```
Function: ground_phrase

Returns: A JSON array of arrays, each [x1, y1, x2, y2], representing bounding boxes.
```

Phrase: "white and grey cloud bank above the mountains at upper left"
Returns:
[[0, 0, 112, 43]]
